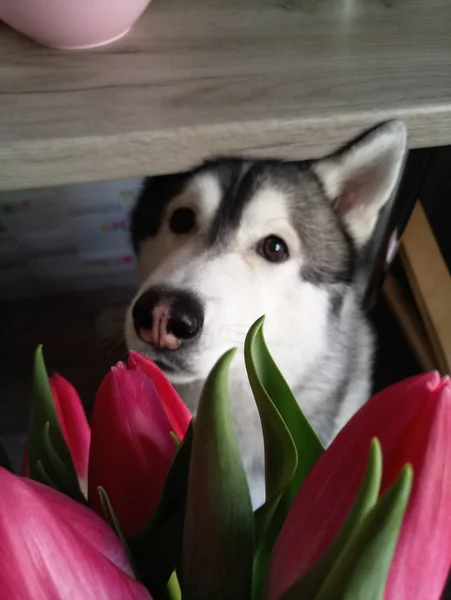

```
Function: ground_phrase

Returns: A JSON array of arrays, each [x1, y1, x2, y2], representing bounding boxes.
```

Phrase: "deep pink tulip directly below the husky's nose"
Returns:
[[88, 353, 191, 534]]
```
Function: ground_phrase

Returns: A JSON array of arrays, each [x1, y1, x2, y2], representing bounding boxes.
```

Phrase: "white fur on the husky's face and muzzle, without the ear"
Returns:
[[126, 181, 328, 504]]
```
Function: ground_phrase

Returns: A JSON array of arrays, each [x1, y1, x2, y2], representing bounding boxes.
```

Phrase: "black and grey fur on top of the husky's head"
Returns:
[[131, 158, 368, 288]]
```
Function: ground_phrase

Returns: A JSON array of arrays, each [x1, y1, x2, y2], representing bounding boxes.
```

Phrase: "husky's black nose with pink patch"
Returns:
[[133, 288, 204, 350]]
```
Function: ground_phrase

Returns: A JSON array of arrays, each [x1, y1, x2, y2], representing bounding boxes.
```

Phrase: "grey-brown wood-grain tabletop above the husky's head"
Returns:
[[0, 0, 451, 189]]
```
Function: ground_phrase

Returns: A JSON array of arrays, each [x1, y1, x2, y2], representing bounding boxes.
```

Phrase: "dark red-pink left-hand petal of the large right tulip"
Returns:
[[267, 373, 440, 600]]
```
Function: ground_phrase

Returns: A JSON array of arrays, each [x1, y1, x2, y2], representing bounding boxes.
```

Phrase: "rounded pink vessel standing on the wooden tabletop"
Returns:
[[0, 0, 150, 50]]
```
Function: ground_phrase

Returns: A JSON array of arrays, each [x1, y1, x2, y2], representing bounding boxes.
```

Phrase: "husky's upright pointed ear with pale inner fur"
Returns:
[[312, 121, 407, 247]]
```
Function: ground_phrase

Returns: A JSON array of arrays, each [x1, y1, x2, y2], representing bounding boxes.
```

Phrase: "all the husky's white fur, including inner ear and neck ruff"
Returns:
[[125, 123, 406, 506]]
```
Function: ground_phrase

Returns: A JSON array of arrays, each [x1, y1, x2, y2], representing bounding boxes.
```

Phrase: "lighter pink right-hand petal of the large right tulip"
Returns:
[[382, 378, 451, 600]]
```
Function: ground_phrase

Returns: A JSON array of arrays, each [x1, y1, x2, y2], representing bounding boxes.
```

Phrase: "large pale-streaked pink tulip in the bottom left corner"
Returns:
[[0, 468, 151, 600]]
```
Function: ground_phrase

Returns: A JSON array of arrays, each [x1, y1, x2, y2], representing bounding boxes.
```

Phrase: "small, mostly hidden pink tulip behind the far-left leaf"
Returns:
[[50, 375, 91, 495]]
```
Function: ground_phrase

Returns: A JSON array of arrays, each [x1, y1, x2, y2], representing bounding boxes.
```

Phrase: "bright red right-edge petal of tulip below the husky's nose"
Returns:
[[128, 350, 192, 440]]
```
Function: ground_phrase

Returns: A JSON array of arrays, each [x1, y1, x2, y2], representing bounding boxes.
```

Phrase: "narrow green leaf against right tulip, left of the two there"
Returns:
[[283, 439, 382, 600]]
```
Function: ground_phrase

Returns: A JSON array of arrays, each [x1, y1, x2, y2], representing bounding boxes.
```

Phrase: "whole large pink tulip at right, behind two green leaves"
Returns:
[[266, 373, 451, 600]]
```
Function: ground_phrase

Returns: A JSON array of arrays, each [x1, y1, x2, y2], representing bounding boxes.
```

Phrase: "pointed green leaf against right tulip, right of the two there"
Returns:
[[315, 466, 412, 600]]
